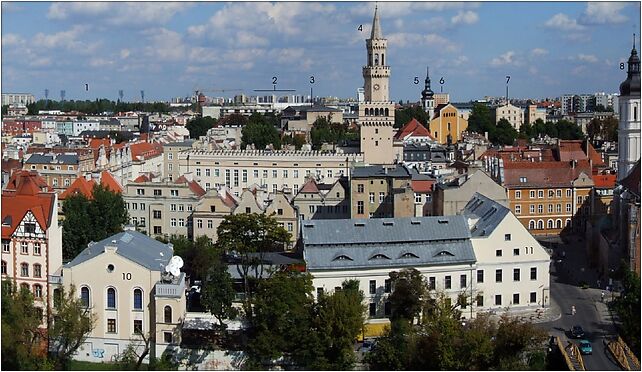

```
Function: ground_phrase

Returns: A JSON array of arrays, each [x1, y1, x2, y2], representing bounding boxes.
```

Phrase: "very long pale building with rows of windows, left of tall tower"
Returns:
[[164, 146, 363, 197]]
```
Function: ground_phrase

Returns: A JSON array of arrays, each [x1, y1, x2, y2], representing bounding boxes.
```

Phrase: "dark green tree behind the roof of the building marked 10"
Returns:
[[62, 184, 129, 260]]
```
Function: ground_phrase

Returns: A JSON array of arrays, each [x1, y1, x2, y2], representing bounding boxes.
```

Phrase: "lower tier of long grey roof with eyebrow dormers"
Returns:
[[304, 239, 476, 270]]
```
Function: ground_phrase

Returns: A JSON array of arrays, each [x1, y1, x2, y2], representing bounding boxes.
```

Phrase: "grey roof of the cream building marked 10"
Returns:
[[64, 230, 173, 271]]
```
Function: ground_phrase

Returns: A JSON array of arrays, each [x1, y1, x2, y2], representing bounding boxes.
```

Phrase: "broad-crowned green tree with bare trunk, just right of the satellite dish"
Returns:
[[216, 213, 291, 317]]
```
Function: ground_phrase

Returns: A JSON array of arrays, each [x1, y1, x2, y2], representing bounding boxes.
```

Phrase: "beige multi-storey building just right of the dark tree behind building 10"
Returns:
[[123, 174, 205, 237]]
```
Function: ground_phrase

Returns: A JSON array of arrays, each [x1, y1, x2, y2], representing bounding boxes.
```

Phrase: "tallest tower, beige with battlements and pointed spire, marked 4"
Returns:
[[359, 6, 401, 164]]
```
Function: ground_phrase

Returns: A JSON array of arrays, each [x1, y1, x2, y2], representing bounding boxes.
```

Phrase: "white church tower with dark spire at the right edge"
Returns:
[[617, 35, 642, 181]]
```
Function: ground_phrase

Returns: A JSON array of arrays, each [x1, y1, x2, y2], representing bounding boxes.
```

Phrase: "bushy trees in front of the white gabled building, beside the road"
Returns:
[[366, 269, 547, 370]]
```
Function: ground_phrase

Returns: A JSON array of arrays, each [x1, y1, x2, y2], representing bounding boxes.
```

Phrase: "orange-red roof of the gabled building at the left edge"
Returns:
[[2, 171, 56, 239]]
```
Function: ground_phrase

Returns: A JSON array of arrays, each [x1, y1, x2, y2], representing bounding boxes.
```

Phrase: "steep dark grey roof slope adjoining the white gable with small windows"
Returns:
[[461, 192, 510, 237]]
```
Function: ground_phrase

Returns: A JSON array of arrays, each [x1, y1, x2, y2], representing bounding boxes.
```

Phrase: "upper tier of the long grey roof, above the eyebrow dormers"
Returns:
[[302, 216, 470, 248]]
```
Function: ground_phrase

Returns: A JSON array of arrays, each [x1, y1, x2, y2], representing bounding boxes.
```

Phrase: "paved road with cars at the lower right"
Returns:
[[541, 237, 620, 371]]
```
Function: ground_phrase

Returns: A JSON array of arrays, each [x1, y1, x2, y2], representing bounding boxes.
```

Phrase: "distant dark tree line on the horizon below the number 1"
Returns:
[[27, 98, 170, 115]]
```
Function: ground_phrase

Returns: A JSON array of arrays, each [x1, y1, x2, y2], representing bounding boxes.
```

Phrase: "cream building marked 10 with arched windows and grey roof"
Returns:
[[59, 230, 186, 362]]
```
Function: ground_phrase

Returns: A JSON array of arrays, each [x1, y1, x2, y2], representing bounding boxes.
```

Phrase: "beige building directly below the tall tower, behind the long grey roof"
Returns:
[[350, 165, 415, 218]]
